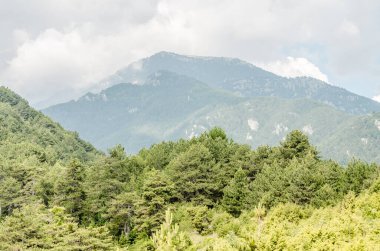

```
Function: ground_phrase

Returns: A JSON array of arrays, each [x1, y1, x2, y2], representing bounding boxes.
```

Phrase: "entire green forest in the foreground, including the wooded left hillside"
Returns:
[[0, 88, 380, 251]]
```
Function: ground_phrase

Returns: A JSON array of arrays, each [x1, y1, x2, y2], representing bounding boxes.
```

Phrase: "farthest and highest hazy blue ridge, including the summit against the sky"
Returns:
[[102, 52, 380, 114]]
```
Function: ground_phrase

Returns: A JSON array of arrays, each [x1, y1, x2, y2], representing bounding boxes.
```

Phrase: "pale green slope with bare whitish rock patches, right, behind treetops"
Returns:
[[176, 97, 380, 163]]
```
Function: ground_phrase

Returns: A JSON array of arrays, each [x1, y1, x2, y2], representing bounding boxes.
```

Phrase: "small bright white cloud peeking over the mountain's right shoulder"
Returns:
[[257, 57, 328, 82]]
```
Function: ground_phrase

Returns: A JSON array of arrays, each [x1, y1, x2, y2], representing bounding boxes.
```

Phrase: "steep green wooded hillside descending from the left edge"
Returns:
[[0, 87, 99, 163]]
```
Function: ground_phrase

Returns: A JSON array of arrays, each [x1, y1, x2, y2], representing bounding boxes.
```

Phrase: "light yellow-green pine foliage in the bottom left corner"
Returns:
[[0, 203, 114, 251]]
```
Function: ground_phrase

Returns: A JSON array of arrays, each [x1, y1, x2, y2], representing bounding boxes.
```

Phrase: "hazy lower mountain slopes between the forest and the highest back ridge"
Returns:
[[43, 65, 380, 162]]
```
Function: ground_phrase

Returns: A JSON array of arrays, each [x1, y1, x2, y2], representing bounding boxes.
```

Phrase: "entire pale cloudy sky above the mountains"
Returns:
[[0, 0, 380, 108]]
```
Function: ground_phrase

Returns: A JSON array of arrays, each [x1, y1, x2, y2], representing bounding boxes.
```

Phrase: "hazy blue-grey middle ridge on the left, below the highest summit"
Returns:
[[43, 71, 241, 152]]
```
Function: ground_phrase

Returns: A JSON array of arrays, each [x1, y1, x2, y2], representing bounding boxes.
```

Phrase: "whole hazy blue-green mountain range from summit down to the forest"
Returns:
[[43, 52, 380, 162]]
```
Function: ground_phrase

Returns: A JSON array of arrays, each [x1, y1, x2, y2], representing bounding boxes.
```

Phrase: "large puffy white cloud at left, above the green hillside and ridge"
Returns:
[[1, 29, 128, 107]]
